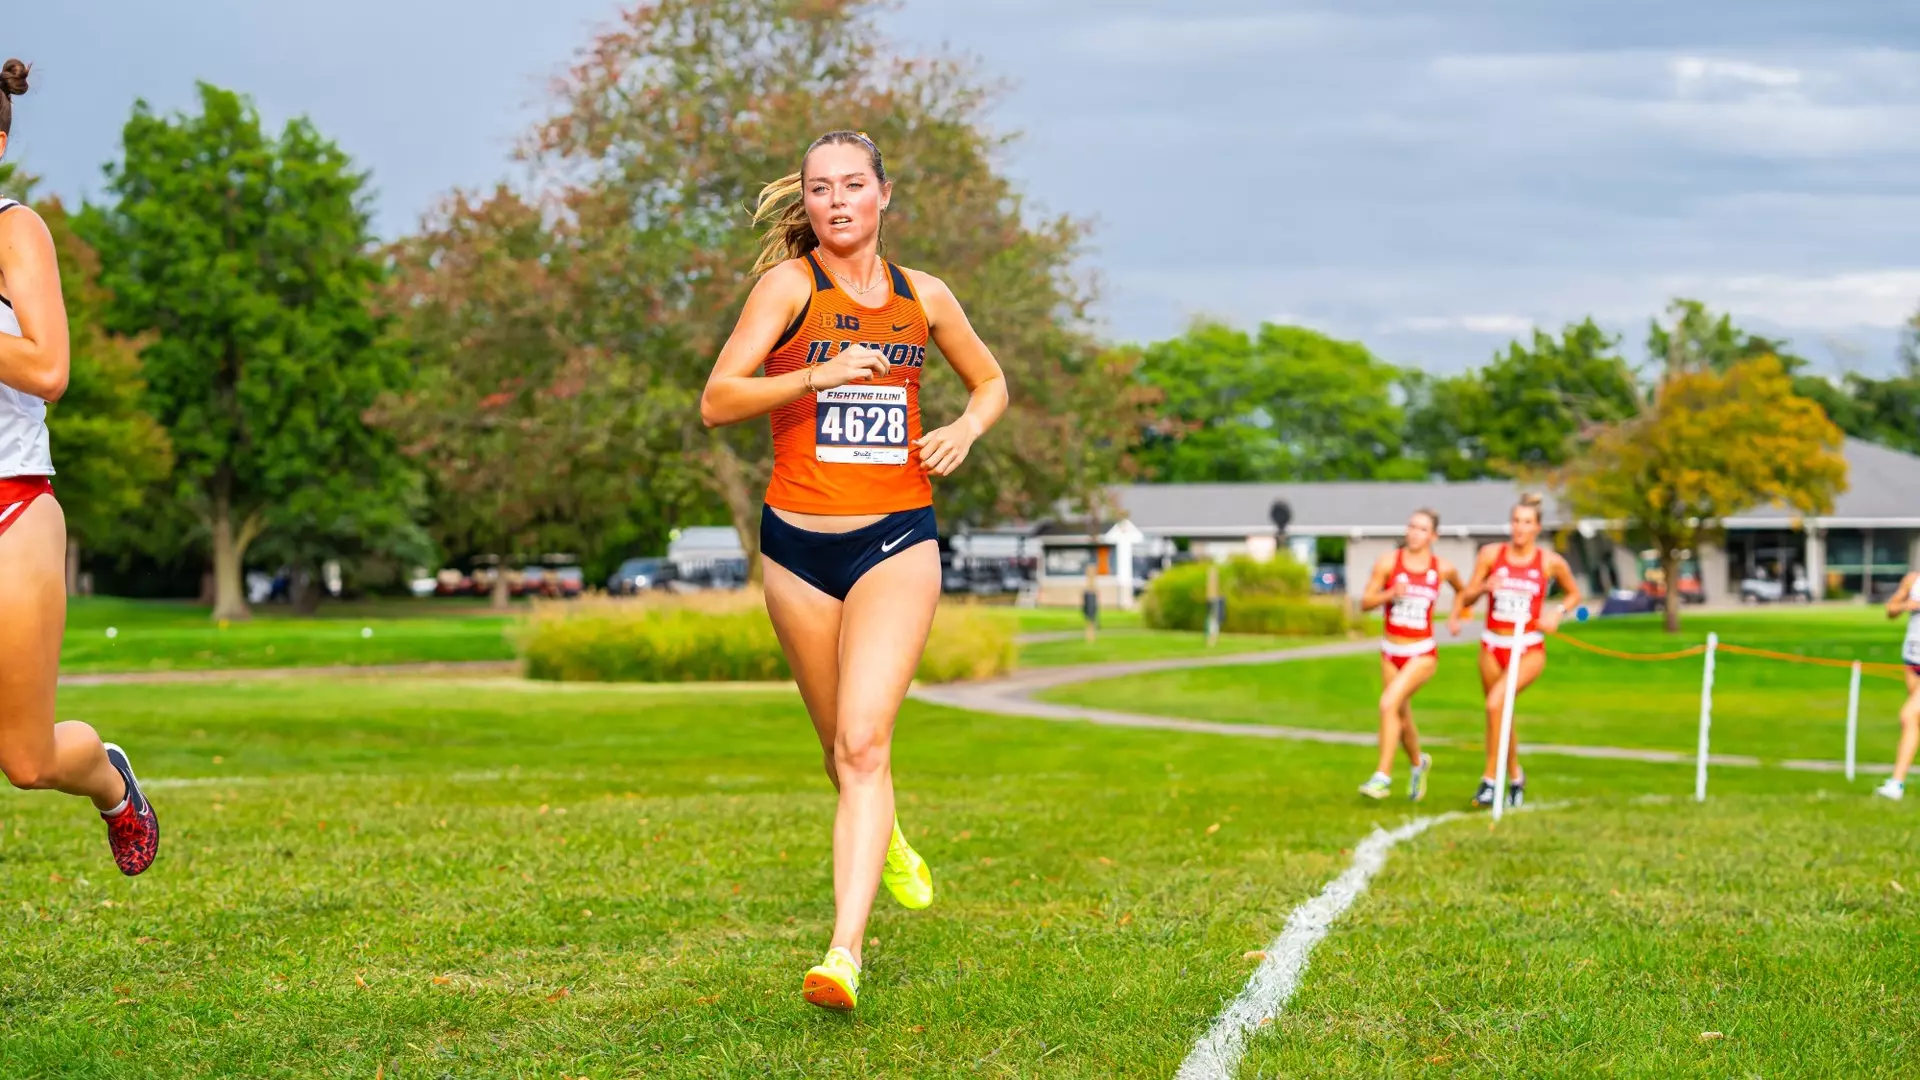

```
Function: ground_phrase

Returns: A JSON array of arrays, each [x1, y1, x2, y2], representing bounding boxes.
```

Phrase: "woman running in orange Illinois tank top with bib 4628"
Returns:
[[701, 131, 1006, 1009]]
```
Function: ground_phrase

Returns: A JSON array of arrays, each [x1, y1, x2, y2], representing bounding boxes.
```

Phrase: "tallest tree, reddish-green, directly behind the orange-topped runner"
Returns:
[[528, 0, 1142, 567]]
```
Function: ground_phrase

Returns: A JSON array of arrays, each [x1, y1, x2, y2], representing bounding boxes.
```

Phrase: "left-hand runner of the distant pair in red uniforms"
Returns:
[[1359, 509, 1465, 801]]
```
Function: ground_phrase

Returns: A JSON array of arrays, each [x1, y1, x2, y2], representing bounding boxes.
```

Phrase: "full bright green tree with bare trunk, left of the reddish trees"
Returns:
[[77, 85, 405, 619]]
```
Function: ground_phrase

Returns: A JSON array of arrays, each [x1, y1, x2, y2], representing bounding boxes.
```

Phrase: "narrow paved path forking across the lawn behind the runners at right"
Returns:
[[912, 628, 1891, 773]]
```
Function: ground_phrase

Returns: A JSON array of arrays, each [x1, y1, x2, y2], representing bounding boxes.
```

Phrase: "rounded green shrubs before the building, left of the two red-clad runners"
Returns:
[[1140, 555, 1348, 636]]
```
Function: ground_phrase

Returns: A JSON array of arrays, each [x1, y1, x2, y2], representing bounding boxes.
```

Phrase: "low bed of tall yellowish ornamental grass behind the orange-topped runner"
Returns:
[[518, 592, 1016, 682]]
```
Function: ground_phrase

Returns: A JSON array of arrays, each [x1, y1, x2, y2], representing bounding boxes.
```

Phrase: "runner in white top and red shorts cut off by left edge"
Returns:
[[0, 60, 159, 874]]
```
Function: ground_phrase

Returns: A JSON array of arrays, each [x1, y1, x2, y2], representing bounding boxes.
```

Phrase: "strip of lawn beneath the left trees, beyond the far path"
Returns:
[[60, 598, 516, 675]]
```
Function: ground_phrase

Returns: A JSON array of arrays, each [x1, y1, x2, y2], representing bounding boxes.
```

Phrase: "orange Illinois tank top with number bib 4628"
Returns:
[[766, 252, 933, 515]]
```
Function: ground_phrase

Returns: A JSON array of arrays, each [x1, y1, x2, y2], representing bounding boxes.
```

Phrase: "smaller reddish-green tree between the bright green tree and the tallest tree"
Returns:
[[374, 188, 691, 607]]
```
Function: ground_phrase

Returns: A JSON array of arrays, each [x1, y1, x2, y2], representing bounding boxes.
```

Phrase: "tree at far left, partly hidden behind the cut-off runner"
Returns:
[[0, 163, 173, 592]]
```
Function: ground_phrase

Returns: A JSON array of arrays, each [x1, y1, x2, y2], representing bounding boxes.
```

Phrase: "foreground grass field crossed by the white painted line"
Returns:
[[0, 665, 1920, 1080]]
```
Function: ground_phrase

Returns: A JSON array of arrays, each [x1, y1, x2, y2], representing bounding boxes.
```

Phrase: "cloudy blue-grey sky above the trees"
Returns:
[[11, 0, 1920, 371]]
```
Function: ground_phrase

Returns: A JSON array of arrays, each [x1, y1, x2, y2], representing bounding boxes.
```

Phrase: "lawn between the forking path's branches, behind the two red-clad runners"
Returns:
[[1046, 607, 1907, 763]]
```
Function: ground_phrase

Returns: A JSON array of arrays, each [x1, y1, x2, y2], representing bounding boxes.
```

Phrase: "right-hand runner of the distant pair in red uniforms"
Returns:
[[1448, 494, 1580, 809]]
